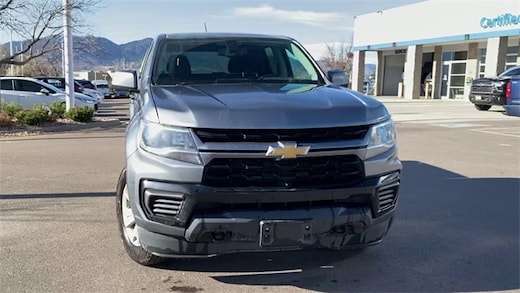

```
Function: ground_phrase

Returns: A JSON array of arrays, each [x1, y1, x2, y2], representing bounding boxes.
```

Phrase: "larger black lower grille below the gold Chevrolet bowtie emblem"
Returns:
[[202, 155, 365, 188]]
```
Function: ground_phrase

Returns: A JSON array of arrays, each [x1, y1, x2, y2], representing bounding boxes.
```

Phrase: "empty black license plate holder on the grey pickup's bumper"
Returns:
[[259, 220, 314, 247]]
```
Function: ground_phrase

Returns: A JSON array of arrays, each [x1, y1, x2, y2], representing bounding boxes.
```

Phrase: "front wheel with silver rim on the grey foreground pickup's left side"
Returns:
[[116, 170, 164, 266]]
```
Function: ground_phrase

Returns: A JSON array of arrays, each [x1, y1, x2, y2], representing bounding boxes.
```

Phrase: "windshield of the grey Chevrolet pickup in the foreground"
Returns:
[[153, 38, 322, 85]]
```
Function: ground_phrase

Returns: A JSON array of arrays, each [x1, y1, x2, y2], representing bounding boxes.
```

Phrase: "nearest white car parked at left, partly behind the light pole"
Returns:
[[0, 76, 98, 111]]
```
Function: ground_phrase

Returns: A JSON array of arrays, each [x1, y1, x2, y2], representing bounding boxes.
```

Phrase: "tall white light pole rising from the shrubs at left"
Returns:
[[63, 0, 74, 111]]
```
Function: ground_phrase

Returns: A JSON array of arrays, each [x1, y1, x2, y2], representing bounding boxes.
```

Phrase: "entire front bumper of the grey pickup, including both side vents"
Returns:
[[126, 139, 401, 257]]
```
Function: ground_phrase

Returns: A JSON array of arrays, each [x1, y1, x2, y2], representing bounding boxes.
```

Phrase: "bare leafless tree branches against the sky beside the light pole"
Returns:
[[0, 0, 99, 66]]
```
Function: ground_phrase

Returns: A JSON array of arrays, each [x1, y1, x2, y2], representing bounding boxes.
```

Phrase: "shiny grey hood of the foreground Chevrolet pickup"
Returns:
[[150, 83, 390, 129]]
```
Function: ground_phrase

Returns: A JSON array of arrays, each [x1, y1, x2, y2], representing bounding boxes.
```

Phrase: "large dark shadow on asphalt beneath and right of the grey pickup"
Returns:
[[159, 161, 520, 292]]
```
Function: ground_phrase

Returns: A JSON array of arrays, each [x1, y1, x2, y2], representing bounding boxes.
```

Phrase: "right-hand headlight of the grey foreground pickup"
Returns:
[[367, 119, 397, 158]]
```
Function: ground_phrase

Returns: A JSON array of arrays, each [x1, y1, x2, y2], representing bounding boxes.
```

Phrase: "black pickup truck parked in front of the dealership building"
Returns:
[[469, 66, 520, 111]]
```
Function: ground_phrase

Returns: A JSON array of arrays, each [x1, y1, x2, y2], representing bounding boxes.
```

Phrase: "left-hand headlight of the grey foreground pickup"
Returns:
[[140, 122, 202, 165]]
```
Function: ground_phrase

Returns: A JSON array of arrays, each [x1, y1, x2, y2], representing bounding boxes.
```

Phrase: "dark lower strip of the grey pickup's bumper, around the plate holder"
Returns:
[[138, 203, 393, 257]]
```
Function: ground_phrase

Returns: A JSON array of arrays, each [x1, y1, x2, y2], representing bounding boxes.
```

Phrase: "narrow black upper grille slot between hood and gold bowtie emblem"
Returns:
[[194, 125, 370, 142]]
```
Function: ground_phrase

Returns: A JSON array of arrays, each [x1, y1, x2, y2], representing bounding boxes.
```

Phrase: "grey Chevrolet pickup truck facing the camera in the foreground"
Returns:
[[112, 33, 402, 265]]
